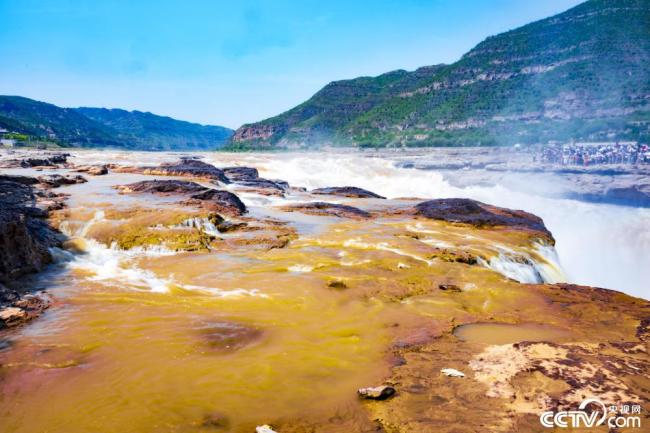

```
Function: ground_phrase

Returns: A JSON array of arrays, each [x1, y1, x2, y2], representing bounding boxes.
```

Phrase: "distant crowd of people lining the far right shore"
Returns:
[[533, 143, 650, 166]]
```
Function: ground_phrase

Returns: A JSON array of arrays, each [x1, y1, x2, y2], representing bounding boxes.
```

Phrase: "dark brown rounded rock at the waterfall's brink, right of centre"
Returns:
[[415, 198, 553, 240]]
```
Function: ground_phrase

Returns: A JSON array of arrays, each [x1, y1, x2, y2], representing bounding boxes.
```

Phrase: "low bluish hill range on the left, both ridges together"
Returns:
[[0, 96, 233, 150]]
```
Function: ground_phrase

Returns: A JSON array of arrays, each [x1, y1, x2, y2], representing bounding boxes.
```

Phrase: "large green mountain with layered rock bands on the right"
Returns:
[[229, 0, 650, 149]]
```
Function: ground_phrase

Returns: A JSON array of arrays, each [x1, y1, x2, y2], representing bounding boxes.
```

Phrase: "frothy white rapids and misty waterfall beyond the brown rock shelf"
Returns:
[[73, 150, 650, 299]]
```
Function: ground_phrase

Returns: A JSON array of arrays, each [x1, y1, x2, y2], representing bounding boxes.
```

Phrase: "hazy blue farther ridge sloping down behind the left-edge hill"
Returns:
[[77, 107, 233, 150]]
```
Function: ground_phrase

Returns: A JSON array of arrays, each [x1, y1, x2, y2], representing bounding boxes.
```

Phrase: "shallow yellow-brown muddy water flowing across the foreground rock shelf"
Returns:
[[0, 162, 564, 433]]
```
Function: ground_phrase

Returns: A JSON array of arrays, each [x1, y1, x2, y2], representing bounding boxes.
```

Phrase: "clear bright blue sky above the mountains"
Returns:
[[0, 0, 580, 128]]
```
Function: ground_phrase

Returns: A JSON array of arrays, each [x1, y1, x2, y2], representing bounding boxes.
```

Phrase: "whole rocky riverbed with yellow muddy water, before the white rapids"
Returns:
[[0, 152, 650, 433]]
